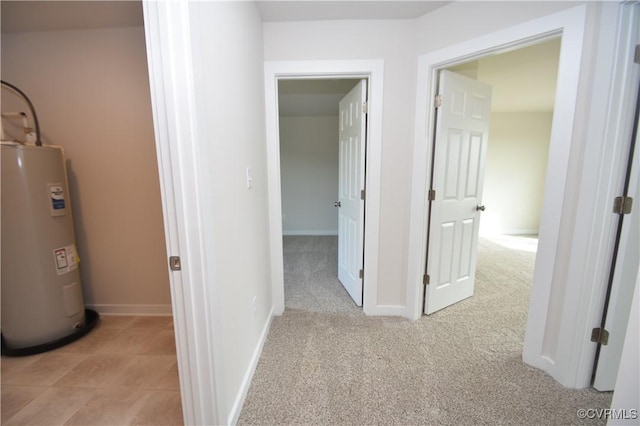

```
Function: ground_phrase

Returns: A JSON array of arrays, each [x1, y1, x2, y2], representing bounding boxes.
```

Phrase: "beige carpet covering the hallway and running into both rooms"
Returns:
[[239, 237, 611, 425]]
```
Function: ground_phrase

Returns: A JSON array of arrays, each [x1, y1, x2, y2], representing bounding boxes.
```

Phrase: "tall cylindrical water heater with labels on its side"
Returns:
[[1, 142, 88, 353]]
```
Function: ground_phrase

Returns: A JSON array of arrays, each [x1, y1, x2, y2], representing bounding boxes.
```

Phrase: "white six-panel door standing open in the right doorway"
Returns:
[[424, 70, 491, 314]]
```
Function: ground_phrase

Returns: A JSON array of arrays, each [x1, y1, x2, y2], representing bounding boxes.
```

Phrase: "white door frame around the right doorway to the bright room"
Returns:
[[408, 7, 588, 386]]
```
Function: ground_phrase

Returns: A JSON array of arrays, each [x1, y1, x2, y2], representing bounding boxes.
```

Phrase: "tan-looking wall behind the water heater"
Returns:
[[2, 27, 171, 314]]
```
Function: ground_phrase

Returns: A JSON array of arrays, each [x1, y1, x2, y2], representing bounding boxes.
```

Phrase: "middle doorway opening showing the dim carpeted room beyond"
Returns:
[[278, 79, 364, 313]]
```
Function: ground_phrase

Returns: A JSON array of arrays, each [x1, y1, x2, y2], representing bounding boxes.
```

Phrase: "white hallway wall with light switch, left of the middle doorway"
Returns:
[[189, 2, 272, 424]]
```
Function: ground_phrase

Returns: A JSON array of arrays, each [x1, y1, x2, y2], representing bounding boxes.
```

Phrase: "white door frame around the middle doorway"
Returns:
[[264, 60, 384, 315]]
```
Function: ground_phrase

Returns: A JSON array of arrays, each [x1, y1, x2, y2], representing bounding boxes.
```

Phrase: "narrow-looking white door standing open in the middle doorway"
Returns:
[[338, 80, 367, 306]]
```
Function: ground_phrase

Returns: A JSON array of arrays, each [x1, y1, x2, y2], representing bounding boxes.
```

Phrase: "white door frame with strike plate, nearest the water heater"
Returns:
[[142, 1, 220, 424]]
